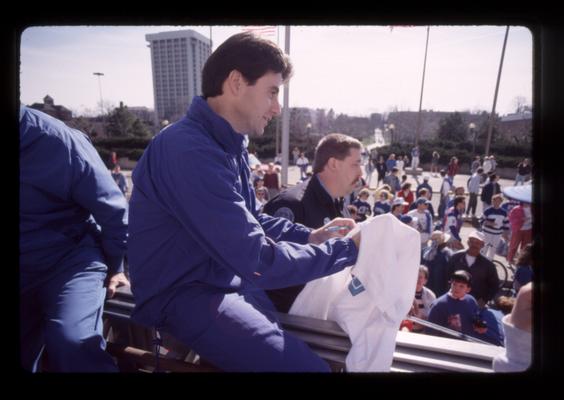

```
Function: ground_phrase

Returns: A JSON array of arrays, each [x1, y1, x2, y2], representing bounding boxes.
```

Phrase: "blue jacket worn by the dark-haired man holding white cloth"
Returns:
[[128, 97, 358, 325]]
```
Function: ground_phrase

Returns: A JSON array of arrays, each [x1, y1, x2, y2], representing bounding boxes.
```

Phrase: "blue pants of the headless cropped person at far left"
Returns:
[[20, 262, 118, 372]]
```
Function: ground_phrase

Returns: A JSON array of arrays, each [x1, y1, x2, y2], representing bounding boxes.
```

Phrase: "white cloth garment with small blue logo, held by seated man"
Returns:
[[289, 213, 421, 372]]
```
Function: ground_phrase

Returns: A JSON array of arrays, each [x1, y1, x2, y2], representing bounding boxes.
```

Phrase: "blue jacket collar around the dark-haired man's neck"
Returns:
[[186, 96, 245, 155]]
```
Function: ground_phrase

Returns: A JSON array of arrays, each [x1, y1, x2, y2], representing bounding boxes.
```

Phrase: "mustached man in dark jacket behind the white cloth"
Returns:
[[263, 133, 362, 313]]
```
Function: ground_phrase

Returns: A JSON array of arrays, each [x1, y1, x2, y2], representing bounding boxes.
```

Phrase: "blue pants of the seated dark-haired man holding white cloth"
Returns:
[[159, 287, 330, 372]]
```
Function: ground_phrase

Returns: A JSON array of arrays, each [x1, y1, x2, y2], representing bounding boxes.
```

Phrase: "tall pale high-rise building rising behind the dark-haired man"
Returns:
[[145, 29, 211, 126]]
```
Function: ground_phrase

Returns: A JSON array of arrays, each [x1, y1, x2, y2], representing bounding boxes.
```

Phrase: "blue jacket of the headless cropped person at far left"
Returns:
[[20, 106, 127, 292]]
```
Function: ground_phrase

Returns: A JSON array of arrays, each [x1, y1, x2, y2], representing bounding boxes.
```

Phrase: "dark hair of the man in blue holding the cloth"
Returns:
[[202, 32, 292, 99]]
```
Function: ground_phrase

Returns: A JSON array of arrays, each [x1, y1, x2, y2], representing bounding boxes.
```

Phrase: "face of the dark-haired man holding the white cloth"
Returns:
[[235, 72, 283, 136]]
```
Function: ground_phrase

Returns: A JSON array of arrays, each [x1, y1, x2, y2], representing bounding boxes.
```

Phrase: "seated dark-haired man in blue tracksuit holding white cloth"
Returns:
[[128, 33, 360, 371]]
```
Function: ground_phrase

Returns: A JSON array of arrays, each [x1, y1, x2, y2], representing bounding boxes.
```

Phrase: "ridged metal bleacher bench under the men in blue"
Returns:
[[104, 287, 503, 372]]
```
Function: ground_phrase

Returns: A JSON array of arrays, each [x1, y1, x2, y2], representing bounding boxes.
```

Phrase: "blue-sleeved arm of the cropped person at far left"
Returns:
[[71, 133, 128, 276]]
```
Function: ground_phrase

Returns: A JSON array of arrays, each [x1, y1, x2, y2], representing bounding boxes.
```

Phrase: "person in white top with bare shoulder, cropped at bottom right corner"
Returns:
[[492, 282, 533, 372]]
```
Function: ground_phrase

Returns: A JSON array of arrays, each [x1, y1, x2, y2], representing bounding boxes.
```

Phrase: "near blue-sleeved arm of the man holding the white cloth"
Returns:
[[153, 145, 358, 289]]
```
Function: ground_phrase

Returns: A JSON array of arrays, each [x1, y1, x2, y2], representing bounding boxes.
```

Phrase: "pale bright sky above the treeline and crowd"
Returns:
[[20, 26, 533, 115]]
